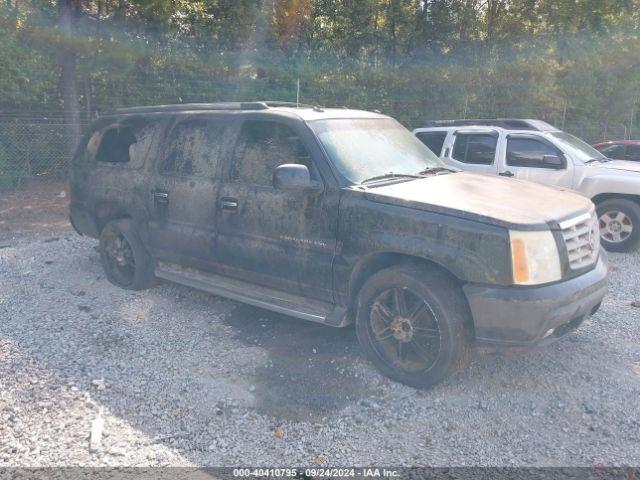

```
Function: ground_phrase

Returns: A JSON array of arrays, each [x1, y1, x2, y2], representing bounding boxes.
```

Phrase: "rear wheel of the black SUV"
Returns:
[[100, 219, 155, 290]]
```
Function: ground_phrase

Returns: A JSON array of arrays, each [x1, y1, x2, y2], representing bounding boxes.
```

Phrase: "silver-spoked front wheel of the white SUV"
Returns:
[[596, 198, 640, 252]]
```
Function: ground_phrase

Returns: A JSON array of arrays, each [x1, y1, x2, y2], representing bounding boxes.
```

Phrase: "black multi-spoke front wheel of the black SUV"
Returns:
[[356, 266, 471, 388]]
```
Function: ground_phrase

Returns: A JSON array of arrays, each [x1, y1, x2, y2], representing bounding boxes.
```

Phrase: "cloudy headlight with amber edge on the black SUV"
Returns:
[[509, 230, 562, 285]]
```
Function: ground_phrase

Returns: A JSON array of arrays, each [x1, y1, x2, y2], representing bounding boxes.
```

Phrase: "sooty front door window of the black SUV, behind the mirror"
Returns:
[[230, 120, 317, 186]]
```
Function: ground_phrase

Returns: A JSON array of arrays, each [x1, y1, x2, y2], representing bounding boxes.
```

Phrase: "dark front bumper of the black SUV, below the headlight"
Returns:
[[463, 251, 607, 346]]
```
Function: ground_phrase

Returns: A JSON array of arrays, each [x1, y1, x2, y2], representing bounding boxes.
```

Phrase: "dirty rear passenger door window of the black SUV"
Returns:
[[160, 118, 226, 177]]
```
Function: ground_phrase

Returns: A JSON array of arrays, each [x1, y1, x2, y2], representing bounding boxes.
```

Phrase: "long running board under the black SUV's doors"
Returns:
[[155, 262, 351, 327]]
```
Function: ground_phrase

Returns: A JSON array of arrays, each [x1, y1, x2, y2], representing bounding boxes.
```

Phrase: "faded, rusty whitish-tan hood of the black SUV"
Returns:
[[365, 172, 593, 229]]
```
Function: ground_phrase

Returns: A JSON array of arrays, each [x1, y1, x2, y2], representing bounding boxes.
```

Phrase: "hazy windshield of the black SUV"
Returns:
[[309, 118, 445, 183]]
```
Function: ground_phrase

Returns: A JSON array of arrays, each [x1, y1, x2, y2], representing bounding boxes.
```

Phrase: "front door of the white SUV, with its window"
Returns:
[[499, 133, 573, 188]]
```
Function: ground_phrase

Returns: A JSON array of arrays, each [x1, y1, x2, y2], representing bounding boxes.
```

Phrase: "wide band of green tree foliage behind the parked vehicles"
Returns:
[[0, 0, 640, 140]]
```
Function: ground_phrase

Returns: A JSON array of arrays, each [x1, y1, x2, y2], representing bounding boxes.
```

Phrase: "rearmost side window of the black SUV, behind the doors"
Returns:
[[87, 119, 158, 168]]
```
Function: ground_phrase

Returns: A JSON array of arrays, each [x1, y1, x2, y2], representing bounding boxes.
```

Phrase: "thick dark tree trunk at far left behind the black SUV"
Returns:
[[58, 0, 80, 165]]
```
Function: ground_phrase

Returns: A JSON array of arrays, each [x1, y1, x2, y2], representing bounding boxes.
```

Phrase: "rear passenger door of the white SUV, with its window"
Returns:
[[443, 129, 499, 175]]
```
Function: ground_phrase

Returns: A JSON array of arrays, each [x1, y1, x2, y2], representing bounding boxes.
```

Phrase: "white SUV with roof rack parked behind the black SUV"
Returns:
[[413, 119, 640, 252]]
